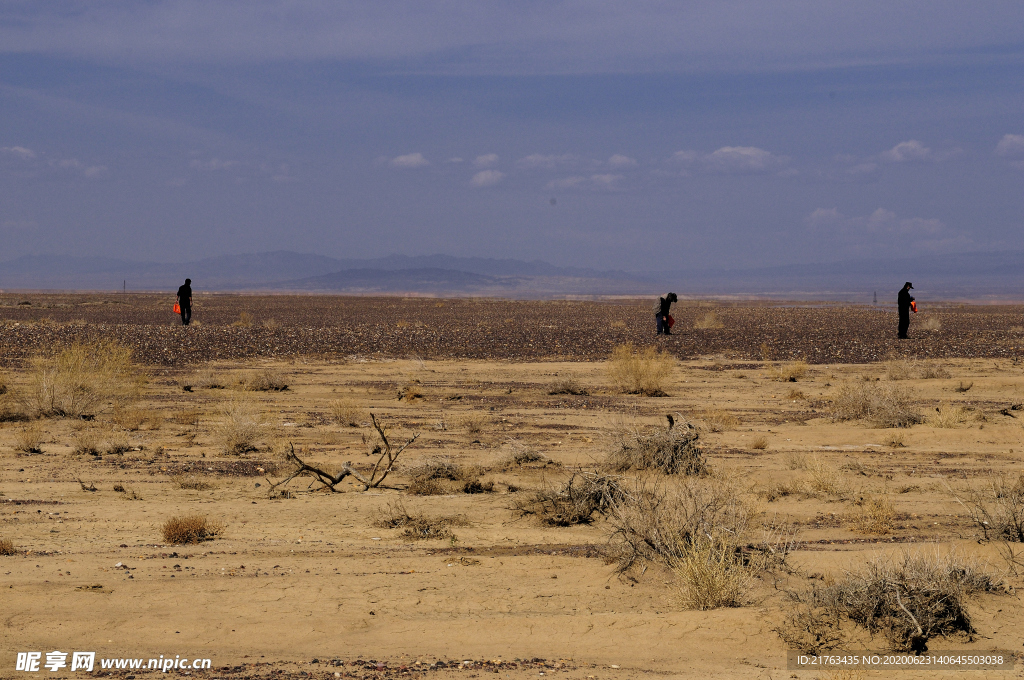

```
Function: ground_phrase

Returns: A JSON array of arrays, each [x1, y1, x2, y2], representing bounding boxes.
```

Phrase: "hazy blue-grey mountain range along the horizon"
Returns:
[[0, 251, 1024, 301]]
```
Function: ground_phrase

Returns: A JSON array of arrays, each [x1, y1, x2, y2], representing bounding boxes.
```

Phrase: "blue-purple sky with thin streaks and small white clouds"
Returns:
[[0, 0, 1024, 269]]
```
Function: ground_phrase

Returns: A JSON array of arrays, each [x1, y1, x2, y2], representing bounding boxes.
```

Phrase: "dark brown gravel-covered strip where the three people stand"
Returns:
[[0, 294, 1024, 366]]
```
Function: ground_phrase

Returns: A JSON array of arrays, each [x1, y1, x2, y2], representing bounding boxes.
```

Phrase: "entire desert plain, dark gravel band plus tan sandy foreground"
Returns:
[[0, 294, 1024, 679]]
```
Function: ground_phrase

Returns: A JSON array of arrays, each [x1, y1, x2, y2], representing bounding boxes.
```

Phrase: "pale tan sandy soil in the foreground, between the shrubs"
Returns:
[[0, 317, 1024, 678]]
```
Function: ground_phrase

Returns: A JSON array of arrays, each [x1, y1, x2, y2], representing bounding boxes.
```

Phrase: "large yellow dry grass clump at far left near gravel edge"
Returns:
[[22, 340, 143, 418]]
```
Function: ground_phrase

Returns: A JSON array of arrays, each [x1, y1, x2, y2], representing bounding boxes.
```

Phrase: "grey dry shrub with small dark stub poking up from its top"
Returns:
[[605, 420, 708, 474]]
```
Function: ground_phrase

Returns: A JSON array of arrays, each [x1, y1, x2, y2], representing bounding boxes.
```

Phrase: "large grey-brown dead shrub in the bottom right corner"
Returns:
[[813, 550, 1000, 652]]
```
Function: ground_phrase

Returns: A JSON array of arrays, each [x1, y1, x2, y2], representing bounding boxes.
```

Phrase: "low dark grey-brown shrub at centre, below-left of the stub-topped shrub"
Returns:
[[513, 470, 626, 526]]
